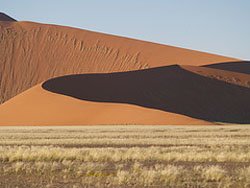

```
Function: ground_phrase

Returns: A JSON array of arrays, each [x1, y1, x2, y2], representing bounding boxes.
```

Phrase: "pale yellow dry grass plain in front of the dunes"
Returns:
[[0, 125, 250, 188]]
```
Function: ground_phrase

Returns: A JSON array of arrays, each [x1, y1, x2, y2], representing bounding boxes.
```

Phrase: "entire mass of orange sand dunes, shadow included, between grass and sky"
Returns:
[[0, 14, 250, 125]]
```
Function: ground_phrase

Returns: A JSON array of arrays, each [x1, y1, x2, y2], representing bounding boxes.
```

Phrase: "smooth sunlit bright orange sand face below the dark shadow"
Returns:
[[0, 85, 212, 126]]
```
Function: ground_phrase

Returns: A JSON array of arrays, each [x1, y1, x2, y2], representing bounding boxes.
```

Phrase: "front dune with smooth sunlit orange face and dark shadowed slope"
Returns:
[[0, 65, 250, 125]]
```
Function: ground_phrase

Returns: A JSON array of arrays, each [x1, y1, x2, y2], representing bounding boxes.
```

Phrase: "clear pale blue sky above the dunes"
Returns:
[[0, 0, 250, 60]]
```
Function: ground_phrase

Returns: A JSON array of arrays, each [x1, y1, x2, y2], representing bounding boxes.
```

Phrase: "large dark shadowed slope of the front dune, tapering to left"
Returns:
[[42, 65, 250, 123]]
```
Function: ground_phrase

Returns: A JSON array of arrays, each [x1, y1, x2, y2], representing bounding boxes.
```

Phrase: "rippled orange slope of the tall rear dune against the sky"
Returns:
[[0, 22, 237, 103]]
